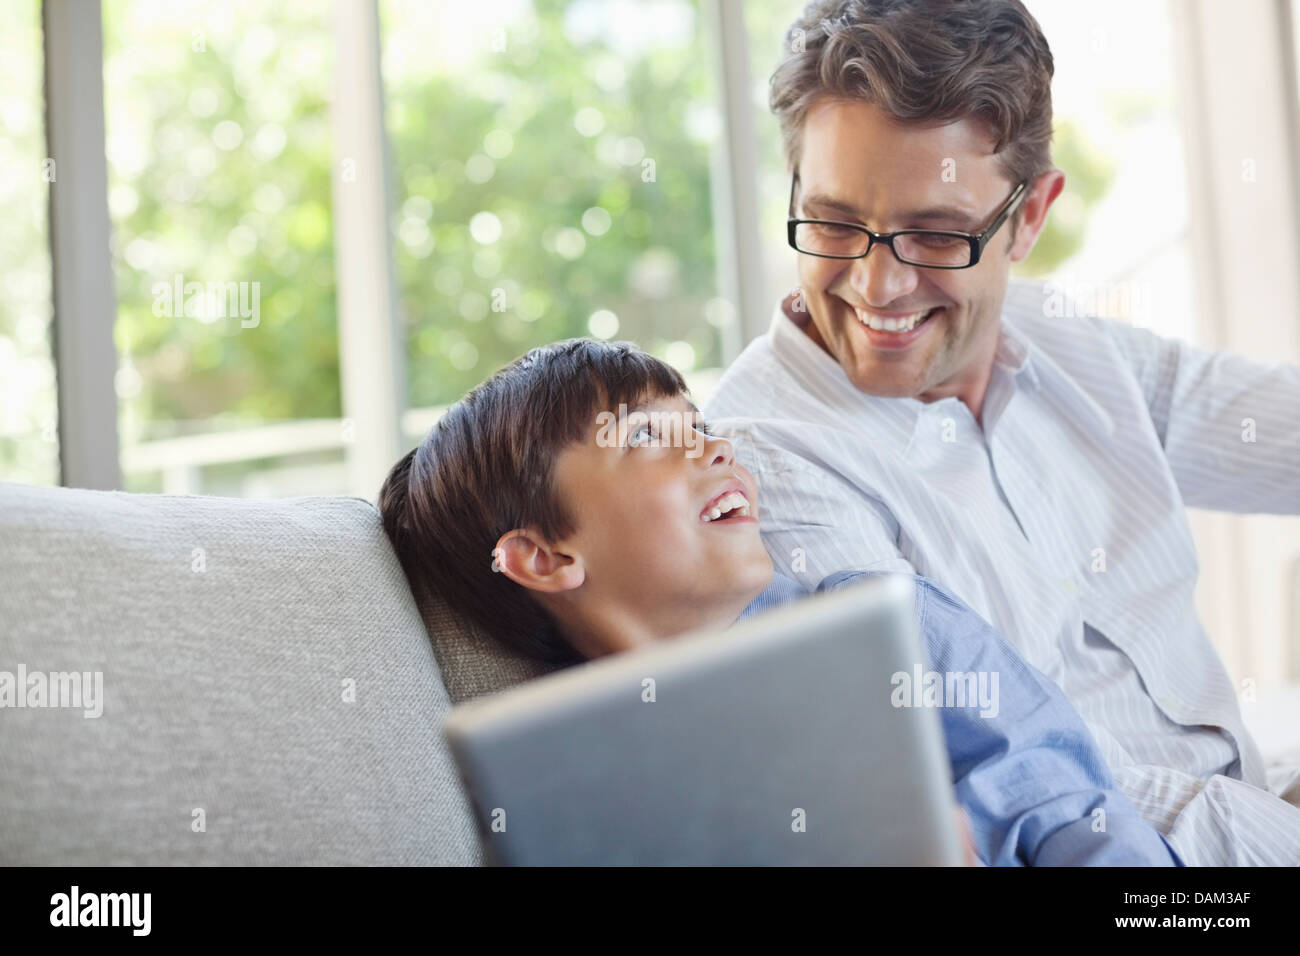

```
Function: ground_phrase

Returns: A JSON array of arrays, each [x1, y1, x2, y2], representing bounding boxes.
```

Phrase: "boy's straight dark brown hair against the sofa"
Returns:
[[380, 338, 688, 666]]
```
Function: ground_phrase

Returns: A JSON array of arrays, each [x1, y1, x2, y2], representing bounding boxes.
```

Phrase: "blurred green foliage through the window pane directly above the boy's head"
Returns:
[[381, 0, 720, 406]]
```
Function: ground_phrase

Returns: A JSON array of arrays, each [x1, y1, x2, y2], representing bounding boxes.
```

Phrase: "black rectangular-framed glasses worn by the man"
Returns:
[[788, 170, 1028, 269]]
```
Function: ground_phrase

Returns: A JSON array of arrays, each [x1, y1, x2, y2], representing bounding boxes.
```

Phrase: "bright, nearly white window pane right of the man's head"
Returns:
[[1017, 0, 1200, 342]]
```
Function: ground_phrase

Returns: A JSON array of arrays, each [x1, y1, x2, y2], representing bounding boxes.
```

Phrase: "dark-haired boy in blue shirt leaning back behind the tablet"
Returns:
[[380, 339, 1182, 865]]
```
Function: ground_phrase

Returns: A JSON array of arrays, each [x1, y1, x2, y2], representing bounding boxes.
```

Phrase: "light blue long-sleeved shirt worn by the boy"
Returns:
[[740, 571, 1183, 866]]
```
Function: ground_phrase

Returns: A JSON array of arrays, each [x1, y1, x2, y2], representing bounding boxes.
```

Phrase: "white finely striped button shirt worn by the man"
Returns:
[[705, 282, 1300, 865]]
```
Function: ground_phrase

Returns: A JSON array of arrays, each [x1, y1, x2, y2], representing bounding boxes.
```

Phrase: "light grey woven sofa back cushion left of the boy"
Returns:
[[0, 485, 482, 865]]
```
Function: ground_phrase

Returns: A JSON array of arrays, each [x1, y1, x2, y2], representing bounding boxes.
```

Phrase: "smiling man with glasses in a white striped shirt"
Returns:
[[706, 0, 1300, 865]]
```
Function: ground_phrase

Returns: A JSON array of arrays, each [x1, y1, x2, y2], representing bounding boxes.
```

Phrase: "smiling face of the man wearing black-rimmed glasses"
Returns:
[[793, 99, 1036, 412]]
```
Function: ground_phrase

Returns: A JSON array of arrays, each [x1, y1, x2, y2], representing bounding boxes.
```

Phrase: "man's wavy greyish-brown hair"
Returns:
[[768, 0, 1054, 196]]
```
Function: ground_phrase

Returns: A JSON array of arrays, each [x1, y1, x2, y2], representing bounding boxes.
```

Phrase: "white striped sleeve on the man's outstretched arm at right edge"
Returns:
[[1097, 320, 1300, 515]]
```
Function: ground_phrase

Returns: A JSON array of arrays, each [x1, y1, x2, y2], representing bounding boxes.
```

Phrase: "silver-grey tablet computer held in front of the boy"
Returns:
[[443, 575, 962, 866]]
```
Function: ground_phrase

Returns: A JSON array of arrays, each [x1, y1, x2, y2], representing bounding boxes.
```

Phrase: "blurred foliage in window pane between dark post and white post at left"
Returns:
[[104, 1, 341, 442]]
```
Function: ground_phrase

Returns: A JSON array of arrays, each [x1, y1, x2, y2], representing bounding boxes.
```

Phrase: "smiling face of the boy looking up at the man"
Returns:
[[535, 395, 772, 656]]
